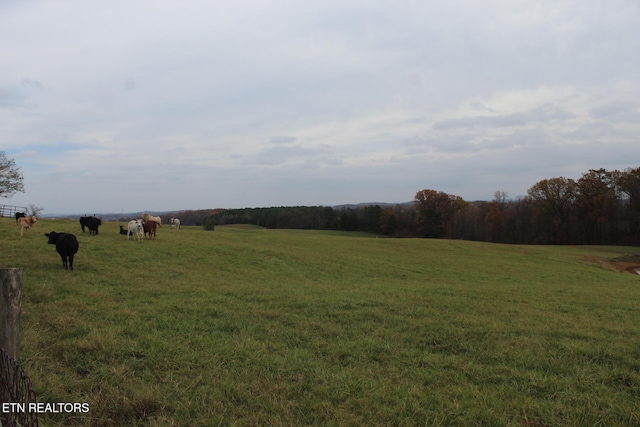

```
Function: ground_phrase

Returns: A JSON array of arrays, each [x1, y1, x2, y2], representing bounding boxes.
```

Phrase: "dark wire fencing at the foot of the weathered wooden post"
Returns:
[[0, 348, 38, 427]]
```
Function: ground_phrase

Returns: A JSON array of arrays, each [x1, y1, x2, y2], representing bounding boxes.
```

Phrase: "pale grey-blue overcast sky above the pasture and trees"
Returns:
[[0, 0, 640, 214]]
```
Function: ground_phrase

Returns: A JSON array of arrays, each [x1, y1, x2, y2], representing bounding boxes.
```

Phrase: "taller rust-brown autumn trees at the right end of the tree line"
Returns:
[[415, 168, 640, 245]]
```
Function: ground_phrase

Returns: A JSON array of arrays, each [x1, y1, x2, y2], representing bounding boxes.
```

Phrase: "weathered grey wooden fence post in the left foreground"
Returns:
[[0, 268, 22, 363]]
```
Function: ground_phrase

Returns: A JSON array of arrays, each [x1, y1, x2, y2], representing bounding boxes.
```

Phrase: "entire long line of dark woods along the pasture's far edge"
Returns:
[[196, 167, 640, 245]]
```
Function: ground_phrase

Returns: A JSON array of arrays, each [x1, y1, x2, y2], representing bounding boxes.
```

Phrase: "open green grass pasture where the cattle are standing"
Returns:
[[0, 218, 640, 426]]
